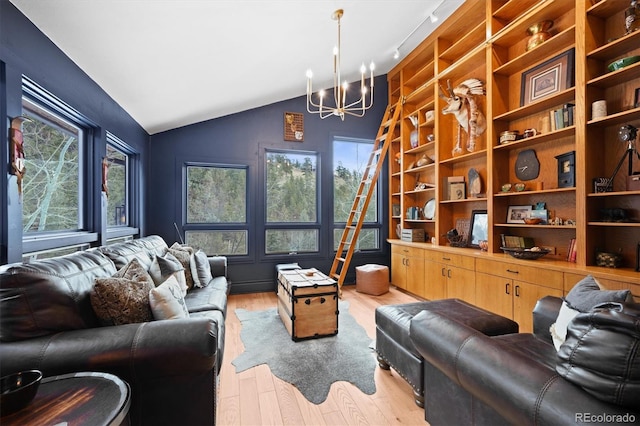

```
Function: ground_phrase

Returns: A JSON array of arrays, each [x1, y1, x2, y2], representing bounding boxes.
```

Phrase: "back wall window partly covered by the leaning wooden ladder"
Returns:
[[333, 138, 380, 250]]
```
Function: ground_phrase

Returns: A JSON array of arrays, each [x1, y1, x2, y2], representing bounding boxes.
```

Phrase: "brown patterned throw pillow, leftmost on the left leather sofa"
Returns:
[[89, 259, 154, 325]]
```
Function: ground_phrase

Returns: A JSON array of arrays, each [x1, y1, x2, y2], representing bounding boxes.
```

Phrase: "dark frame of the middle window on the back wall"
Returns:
[[262, 147, 323, 258]]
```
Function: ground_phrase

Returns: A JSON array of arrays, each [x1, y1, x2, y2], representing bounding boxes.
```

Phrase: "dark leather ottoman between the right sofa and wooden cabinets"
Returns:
[[375, 299, 518, 407]]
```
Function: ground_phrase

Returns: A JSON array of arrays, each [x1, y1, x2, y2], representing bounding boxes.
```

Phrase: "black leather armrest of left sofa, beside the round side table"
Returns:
[[0, 318, 217, 380]]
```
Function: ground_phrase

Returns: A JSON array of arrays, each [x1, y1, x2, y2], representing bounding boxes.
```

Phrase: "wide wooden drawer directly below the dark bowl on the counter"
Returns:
[[476, 259, 564, 290]]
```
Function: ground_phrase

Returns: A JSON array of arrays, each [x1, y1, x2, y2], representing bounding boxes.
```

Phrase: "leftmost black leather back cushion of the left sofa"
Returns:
[[0, 249, 116, 341]]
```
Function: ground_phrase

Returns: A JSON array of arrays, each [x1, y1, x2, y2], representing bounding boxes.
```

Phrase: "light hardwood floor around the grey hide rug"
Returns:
[[217, 286, 427, 426]]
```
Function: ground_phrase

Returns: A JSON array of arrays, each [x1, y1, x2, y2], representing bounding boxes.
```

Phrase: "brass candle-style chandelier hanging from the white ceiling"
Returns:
[[307, 9, 374, 120]]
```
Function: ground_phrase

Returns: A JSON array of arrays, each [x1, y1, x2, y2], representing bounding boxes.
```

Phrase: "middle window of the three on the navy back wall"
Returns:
[[265, 151, 319, 254]]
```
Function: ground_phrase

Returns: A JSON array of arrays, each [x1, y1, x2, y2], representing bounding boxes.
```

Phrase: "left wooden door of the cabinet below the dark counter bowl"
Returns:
[[475, 272, 514, 319]]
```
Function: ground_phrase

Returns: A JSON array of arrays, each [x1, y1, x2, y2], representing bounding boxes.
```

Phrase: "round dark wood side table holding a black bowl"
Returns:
[[0, 372, 131, 426]]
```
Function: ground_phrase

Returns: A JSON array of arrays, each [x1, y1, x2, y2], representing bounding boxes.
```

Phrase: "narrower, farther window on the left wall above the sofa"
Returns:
[[106, 139, 130, 227]]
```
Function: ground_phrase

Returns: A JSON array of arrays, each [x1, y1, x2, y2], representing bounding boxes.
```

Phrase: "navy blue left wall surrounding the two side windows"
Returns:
[[0, 0, 149, 263]]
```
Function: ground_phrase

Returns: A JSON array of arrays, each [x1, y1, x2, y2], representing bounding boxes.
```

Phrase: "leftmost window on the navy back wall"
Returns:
[[185, 165, 249, 256]]
